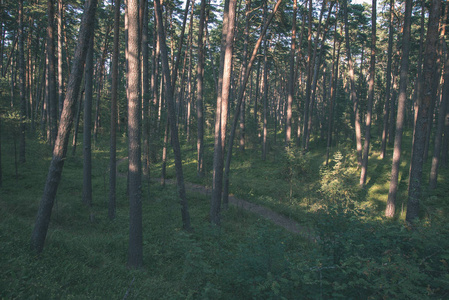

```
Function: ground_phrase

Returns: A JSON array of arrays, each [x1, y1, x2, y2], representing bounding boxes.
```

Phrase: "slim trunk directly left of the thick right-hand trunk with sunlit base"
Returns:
[[380, 0, 394, 159]]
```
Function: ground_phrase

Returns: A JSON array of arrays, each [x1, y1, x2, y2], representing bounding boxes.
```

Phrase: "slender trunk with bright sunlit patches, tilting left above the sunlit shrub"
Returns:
[[343, 0, 362, 165]]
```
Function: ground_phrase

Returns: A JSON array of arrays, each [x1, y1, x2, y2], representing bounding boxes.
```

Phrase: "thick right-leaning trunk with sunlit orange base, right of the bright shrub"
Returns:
[[385, 0, 412, 218]]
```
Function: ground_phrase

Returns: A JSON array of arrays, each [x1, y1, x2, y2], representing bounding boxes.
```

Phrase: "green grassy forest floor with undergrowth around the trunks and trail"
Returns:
[[0, 131, 449, 299]]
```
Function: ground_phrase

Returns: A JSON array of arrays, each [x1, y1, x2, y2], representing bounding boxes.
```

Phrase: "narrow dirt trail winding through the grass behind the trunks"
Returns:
[[117, 157, 317, 241]]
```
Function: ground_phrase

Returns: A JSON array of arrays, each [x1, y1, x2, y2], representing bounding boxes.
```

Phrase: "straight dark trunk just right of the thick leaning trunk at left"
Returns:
[[83, 35, 94, 207]]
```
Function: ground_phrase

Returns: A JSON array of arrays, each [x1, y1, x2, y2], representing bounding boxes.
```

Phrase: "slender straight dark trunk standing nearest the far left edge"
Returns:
[[18, 0, 27, 163]]
